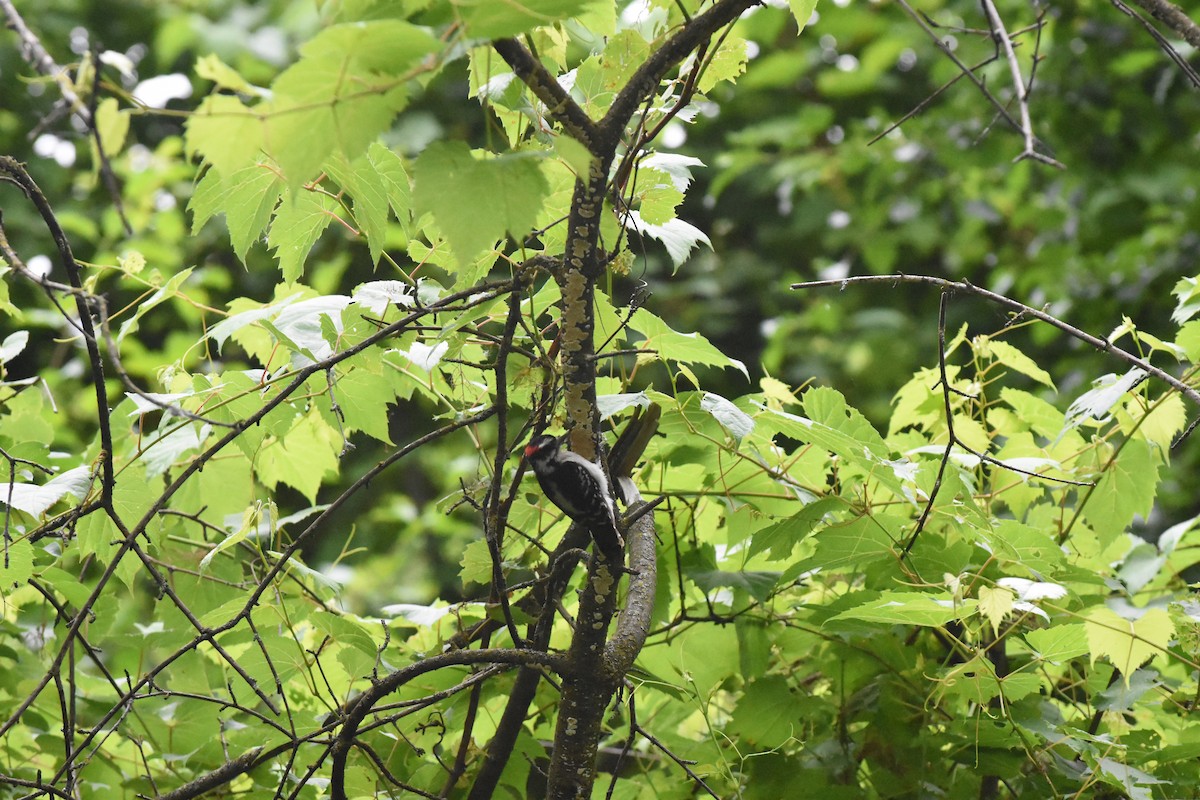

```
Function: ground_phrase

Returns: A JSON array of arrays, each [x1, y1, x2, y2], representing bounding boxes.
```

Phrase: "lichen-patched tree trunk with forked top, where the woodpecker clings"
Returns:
[[482, 0, 758, 800]]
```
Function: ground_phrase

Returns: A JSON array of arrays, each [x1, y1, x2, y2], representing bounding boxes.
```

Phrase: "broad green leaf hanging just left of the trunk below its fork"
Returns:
[[413, 142, 550, 266]]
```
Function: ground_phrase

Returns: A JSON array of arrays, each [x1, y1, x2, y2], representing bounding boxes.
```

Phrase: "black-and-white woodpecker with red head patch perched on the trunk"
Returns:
[[524, 434, 625, 561]]
